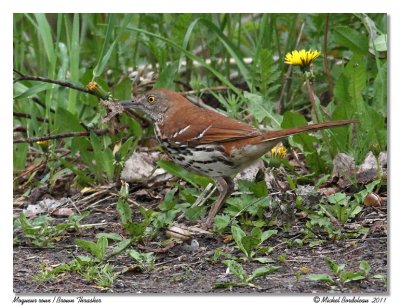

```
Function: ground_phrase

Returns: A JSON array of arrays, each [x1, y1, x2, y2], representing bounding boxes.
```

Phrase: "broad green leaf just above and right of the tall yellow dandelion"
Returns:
[[333, 26, 368, 55]]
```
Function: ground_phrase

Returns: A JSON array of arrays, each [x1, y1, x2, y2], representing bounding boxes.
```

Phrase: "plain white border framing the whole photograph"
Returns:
[[0, 0, 400, 305]]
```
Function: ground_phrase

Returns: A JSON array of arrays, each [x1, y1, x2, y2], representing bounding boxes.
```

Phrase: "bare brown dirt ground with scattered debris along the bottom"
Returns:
[[13, 194, 388, 294]]
